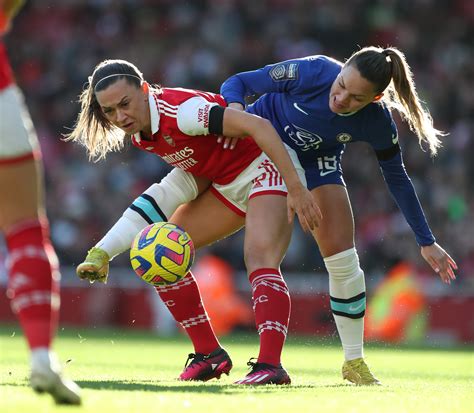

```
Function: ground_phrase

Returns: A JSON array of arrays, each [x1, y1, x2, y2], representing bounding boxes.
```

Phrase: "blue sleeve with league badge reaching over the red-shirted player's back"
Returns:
[[220, 56, 324, 106]]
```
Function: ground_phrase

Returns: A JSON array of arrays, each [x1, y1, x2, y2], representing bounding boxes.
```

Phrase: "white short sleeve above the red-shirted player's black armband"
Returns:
[[176, 96, 219, 136]]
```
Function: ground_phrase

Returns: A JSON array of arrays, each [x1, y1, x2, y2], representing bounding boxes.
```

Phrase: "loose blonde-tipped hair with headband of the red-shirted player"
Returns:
[[65, 60, 143, 161]]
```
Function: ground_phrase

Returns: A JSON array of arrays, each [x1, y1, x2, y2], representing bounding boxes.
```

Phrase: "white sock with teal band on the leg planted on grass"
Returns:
[[324, 248, 366, 360]]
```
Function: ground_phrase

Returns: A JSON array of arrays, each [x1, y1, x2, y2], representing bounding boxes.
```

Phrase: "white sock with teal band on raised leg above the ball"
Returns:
[[96, 168, 198, 259]]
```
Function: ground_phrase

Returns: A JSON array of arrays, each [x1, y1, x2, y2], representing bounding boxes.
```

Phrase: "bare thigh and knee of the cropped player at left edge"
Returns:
[[0, 159, 43, 232]]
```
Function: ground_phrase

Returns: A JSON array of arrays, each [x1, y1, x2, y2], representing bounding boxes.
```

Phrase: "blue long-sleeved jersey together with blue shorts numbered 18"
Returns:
[[221, 55, 435, 245]]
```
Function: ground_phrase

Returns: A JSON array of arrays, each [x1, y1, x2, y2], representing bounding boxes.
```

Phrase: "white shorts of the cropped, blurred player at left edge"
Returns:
[[0, 85, 39, 165]]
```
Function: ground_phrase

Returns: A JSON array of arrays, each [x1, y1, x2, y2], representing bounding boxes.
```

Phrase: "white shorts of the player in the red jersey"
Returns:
[[211, 145, 306, 216]]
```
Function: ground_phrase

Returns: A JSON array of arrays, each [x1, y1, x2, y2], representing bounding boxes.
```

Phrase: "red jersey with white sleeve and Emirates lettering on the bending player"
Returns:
[[132, 88, 262, 185]]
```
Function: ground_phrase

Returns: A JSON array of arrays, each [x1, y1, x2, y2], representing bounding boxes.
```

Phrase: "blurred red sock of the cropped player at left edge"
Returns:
[[6, 217, 60, 349]]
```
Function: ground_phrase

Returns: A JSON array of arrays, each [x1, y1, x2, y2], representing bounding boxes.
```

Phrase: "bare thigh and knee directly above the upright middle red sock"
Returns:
[[244, 195, 292, 272]]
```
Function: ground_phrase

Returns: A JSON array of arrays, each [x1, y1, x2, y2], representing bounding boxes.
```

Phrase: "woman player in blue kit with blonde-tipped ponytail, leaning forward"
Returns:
[[221, 47, 457, 385]]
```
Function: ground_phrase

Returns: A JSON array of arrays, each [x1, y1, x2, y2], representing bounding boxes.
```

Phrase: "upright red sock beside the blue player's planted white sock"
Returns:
[[249, 268, 291, 366]]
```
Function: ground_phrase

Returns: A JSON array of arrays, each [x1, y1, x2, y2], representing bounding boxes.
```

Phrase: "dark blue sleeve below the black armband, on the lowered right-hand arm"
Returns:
[[377, 150, 435, 246]]
